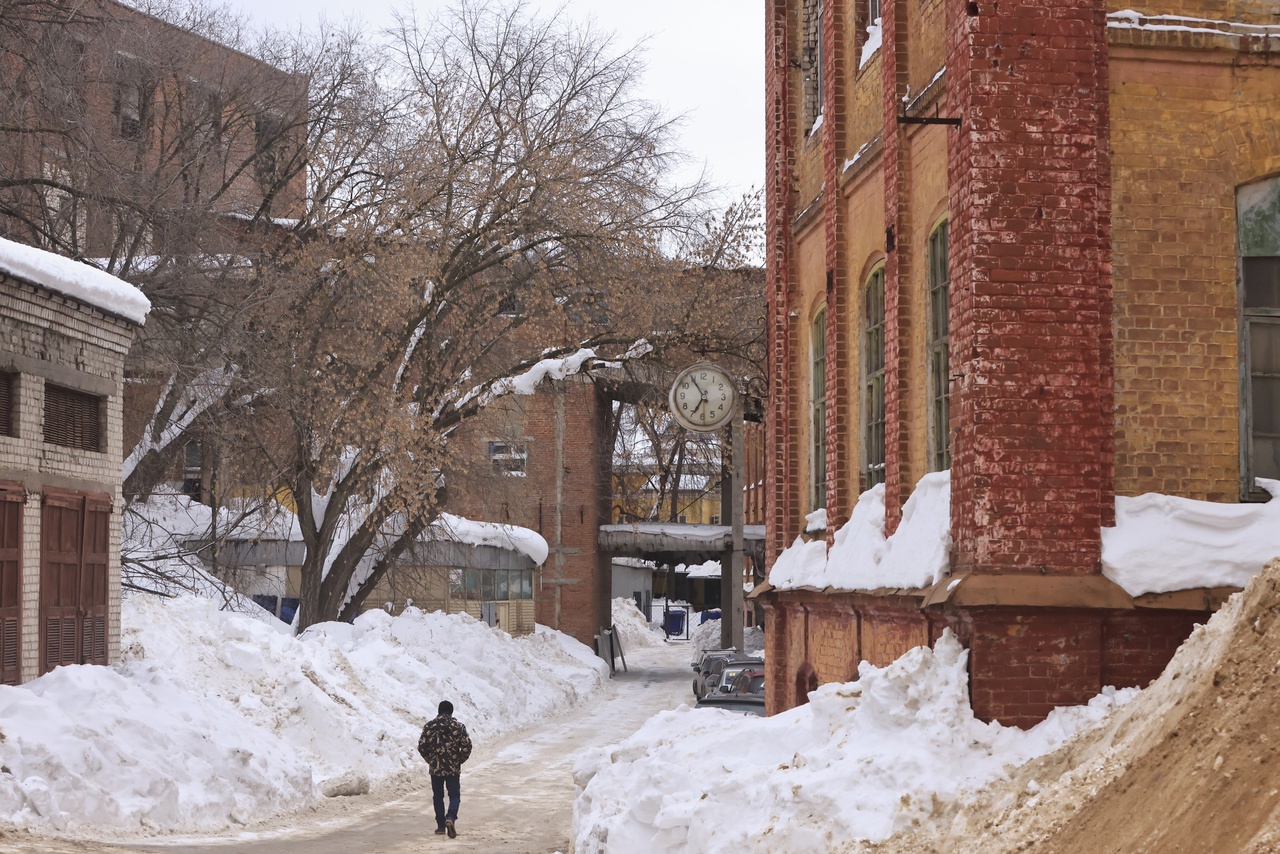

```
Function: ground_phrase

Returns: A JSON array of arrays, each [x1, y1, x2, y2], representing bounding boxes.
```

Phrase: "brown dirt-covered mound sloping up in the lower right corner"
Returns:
[[875, 560, 1280, 854]]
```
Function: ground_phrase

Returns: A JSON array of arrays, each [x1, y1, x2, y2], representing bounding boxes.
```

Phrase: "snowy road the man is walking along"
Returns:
[[0, 645, 692, 854]]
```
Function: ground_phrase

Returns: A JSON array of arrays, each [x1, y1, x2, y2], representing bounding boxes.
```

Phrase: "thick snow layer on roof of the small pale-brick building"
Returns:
[[0, 237, 151, 325]]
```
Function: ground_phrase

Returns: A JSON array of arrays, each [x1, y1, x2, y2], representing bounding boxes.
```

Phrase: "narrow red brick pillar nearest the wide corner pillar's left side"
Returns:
[[885, 0, 923, 535]]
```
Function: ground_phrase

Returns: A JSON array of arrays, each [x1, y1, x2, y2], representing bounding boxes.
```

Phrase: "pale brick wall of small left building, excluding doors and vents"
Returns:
[[0, 274, 133, 681]]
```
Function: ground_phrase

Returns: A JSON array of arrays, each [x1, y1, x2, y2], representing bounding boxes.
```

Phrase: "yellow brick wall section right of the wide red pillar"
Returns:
[[1111, 43, 1280, 501]]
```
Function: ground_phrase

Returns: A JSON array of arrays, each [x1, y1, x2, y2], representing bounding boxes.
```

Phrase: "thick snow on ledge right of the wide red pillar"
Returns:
[[1102, 478, 1280, 597]]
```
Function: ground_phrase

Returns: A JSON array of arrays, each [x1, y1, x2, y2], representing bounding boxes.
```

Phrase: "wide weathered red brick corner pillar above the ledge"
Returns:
[[947, 0, 1114, 576]]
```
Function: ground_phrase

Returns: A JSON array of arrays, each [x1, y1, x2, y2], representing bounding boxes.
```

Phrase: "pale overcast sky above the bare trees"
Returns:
[[218, 0, 764, 195]]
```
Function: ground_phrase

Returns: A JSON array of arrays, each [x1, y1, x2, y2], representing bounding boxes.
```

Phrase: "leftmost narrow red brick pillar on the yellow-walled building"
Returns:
[[764, 0, 800, 565]]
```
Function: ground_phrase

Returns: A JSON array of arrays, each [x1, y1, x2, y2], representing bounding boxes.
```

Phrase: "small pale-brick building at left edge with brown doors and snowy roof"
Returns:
[[0, 248, 145, 685]]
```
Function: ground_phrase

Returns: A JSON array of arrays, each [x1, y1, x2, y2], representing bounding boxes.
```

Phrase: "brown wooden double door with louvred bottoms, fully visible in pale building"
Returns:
[[40, 492, 111, 673]]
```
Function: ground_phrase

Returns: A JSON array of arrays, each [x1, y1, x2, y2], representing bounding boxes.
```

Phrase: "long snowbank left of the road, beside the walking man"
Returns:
[[0, 597, 608, 834]]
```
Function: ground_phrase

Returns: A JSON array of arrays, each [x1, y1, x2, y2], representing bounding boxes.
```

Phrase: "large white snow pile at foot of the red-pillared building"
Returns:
[[573, 631, 1137, 854]]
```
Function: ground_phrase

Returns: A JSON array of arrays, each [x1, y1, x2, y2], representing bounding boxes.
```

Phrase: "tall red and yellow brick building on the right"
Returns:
[[762, 0, 1280, 725]]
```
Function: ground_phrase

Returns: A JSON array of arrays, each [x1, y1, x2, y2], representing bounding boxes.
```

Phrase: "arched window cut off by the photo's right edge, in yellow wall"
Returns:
[[1236, 178, 1280, 497]]
